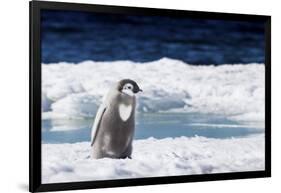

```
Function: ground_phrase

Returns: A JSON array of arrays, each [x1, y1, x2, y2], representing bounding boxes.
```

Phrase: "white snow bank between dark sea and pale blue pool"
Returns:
[[42, 58, 265, 122]]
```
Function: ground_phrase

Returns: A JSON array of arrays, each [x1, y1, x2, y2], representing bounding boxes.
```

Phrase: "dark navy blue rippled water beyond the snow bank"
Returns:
[[41, 10, 264, 64]]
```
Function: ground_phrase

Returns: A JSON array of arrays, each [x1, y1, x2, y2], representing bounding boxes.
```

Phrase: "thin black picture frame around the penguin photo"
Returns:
[[29, 1, 271, 192]]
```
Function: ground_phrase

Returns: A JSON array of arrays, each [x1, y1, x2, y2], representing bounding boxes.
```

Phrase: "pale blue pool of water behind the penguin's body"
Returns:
[[42, 113, 264, 143]]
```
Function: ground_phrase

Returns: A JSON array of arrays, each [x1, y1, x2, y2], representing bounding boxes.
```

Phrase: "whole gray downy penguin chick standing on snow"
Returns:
[[91, 79, 142, 159]]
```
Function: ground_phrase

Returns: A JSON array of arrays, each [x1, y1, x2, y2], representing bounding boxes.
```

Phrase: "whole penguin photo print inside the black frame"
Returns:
[[40, 9, 265, 184]]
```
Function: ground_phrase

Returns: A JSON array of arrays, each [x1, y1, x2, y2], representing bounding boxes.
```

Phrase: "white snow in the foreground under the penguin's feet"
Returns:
[[42, 134, 265, 183]]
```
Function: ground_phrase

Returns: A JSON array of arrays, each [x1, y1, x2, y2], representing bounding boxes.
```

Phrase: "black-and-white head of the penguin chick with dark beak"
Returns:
[[118, 79, 142, 96]]
